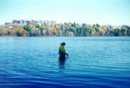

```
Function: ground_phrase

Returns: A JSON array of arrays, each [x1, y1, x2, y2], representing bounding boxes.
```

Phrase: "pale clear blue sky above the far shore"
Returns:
[[0, 0, 130, 26]]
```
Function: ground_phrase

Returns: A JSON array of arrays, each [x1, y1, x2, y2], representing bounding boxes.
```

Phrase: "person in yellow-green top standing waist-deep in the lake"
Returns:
[[59, 42, 68, 66]]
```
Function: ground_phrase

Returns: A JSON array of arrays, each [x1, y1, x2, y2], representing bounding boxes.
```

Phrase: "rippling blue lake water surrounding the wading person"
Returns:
[[0, 37, 130, 88]]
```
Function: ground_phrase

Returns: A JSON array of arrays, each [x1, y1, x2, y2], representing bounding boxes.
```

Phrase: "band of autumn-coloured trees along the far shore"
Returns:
[[0, 22, 130, 36]]
